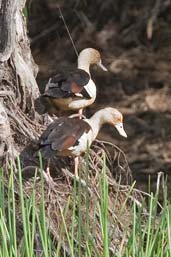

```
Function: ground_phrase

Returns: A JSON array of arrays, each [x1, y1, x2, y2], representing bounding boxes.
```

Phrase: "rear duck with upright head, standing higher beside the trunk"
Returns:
[[42, 48, 107, 117]]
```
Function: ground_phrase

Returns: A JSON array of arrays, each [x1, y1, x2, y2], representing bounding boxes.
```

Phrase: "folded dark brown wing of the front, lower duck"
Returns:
[[39, 117, 91, 158]]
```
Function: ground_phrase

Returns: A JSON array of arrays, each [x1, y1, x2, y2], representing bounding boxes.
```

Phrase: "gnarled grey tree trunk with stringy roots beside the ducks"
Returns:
[[0, 0, 39, 166]]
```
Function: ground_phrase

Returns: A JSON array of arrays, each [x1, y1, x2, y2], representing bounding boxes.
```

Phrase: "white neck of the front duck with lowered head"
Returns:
[[87, 110, 106, 140]]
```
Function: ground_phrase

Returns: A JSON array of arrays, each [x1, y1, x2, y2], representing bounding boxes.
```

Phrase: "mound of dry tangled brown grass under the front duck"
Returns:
[[14, 141, 142, 254]]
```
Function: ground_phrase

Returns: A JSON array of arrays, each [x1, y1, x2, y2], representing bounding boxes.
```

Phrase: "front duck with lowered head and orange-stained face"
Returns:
[[39, 107, 127, 177]]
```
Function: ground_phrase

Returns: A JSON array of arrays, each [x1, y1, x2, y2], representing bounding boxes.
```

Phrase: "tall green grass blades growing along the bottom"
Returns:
[[0, 155, 171, 257]]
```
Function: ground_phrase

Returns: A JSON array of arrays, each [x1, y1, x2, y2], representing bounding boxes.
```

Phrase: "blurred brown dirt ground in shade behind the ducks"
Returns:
[[28, 0, 171, 192]]
